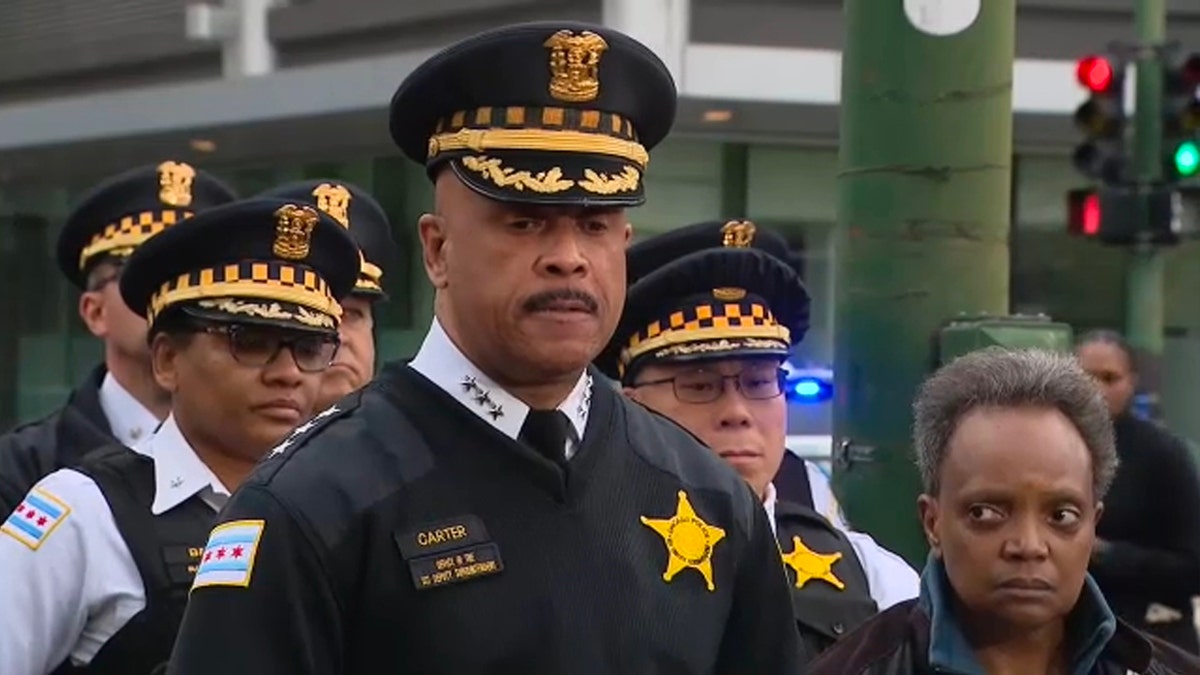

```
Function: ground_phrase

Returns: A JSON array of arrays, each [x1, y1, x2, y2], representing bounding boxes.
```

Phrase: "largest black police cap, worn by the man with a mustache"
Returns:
[[390, 22, 677, 207]]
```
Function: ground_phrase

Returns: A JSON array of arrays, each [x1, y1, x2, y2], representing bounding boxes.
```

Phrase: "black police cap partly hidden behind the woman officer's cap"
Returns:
[[258, 178, 396, 299]]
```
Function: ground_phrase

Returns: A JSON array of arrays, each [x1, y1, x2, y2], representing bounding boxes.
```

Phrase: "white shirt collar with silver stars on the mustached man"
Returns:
[[409, 318, 592, 442]]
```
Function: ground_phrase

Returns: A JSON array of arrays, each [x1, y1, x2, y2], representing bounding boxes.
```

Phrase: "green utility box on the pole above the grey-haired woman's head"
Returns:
[[934, 315, 1074, 369]]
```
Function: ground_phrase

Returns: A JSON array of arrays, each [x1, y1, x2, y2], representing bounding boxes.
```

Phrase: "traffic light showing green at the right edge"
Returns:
[[1163, 54, 1200, 183]]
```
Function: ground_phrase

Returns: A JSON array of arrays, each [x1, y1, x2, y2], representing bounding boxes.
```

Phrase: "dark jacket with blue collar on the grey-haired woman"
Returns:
[[809, 560, 1200, 675]]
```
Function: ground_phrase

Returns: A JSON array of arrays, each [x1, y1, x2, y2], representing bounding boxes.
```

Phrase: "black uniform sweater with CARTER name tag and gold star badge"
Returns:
[[169, 365, 799, 675]]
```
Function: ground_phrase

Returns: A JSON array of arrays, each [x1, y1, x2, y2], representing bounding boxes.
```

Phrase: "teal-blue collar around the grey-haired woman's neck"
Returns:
[[919, 555, 1117, 675]]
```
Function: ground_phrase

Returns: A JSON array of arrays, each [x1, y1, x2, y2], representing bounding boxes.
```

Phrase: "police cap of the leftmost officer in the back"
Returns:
[[58, 160, 238, 288]]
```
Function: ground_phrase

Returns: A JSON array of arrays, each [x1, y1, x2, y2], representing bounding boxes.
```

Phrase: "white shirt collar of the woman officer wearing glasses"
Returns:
[[146, 414, 229, 515]]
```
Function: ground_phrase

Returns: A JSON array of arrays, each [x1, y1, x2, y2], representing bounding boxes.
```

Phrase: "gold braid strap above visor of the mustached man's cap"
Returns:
[[428, 129, 650, 169]]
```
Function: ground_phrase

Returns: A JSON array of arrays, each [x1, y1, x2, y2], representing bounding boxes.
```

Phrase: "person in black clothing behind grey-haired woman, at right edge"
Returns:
[[1075, 330, 1200, 653]]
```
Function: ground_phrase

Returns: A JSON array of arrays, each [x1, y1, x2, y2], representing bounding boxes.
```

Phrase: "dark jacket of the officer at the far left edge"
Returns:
[[0, 366, 115, 515]]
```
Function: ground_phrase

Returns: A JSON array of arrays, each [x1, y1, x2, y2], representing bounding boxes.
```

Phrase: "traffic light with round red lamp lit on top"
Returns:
[[1073, 54, 1128, 185]]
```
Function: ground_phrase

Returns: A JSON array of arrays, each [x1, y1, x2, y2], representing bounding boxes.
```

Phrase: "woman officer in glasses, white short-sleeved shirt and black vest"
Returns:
[[0, 199, 359, 675]]
